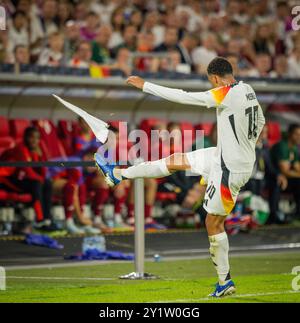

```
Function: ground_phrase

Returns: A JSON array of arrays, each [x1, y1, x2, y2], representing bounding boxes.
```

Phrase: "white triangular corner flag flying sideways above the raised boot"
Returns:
[[53, 94, 109, 143]]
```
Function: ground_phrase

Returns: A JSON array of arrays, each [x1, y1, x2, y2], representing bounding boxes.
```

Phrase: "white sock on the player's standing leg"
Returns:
[[208, 232, 231, 285]]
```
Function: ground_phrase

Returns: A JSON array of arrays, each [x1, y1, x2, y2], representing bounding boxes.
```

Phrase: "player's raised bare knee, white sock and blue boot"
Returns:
[[95, 153, 191, 187]]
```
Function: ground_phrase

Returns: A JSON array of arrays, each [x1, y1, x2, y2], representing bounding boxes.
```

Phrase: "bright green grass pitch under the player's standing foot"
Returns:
[[0, 253, 300, 303]]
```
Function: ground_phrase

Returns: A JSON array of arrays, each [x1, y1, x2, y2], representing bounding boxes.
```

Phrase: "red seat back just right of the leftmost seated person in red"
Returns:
[[33, 120, 67, 159]]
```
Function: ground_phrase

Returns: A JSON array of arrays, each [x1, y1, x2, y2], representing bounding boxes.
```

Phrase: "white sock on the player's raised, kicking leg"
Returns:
[[120, 159, 171, 179]]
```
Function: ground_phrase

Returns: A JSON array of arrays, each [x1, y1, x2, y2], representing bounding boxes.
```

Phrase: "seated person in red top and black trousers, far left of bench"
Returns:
[[3, 127, 57, 230]]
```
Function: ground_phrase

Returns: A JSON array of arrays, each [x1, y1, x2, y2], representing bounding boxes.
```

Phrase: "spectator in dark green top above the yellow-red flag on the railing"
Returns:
[[92, 25, 112, 64]]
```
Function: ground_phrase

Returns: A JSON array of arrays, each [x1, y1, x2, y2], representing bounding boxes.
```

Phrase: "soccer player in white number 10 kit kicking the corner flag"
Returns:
[[95, 57, 265, 297]]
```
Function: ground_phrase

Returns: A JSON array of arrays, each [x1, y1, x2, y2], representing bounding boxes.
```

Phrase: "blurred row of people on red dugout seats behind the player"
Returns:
[[0, 117, 300, 234]]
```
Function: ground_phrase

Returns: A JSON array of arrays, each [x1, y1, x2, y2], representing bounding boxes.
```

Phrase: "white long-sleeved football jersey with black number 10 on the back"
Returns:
[[143, 81, 265, 173]]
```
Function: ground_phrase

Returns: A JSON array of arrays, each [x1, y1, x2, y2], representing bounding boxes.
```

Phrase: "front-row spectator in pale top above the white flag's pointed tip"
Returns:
[[38, 32, 64, 66]]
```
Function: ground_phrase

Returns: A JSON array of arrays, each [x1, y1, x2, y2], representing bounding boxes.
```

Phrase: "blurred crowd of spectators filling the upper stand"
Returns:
[[0, 0, 300, 78]]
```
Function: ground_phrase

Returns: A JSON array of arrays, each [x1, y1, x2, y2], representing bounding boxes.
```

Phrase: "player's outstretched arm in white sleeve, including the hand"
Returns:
[[126, 76, 211, 106]]
